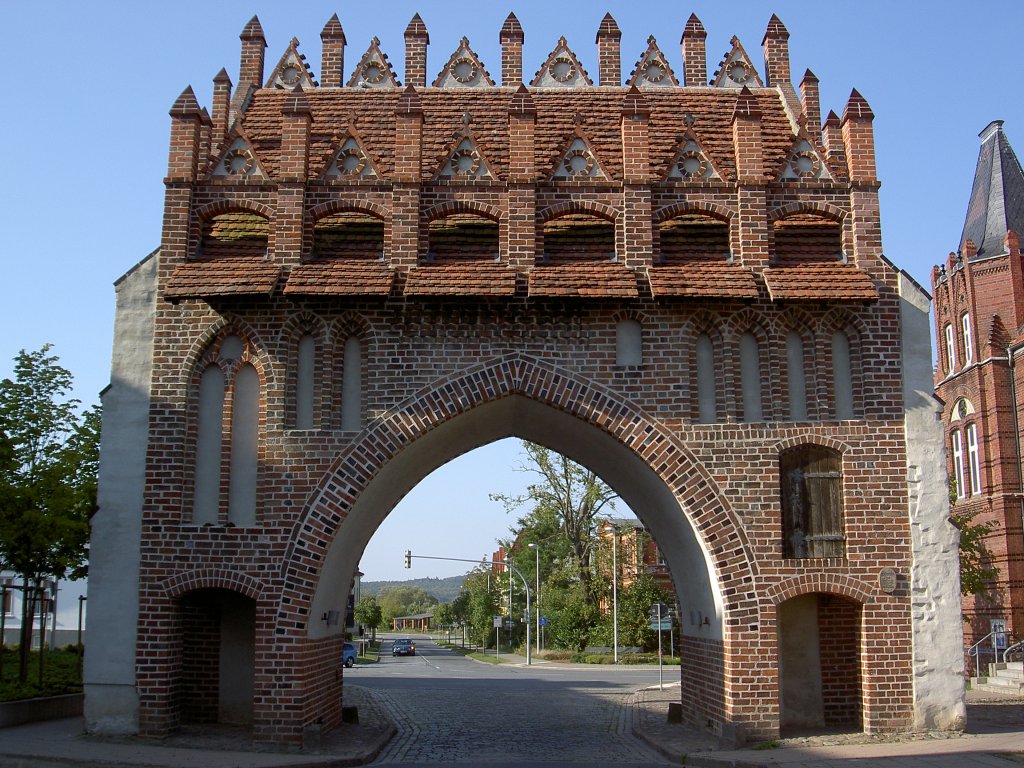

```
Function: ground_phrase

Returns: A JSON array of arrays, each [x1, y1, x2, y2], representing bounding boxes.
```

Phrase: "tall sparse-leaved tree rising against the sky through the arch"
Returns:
[[490, 441, 615, 604]]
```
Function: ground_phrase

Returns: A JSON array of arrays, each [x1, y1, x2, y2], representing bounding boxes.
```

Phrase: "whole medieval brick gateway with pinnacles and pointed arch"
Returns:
[[86, 9, 964, 744]]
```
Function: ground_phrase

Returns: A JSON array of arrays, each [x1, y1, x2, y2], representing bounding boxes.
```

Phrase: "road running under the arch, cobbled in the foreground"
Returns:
[[353, 639, 668, 768]]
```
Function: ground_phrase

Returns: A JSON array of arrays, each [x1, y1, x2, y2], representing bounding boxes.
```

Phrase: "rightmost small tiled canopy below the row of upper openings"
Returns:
[[764, 261, 879, 303]]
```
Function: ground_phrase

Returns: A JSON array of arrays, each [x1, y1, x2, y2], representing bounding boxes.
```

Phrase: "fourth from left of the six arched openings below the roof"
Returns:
[[537, 204, 617, 265]]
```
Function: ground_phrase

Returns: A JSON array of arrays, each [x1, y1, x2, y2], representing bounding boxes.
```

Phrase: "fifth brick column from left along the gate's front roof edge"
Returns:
[[620, 85, 653, 268]]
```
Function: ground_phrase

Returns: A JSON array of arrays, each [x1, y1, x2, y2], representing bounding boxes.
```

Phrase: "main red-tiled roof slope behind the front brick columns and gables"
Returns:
[[237, 88, 794, 181]]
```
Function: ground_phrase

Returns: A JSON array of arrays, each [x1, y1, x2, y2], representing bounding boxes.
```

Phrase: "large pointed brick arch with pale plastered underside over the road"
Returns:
[[276, 355, 758, 741]]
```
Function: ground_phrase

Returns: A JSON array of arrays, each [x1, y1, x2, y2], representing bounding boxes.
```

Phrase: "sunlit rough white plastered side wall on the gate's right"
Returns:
[[899, 273, 966, 730]]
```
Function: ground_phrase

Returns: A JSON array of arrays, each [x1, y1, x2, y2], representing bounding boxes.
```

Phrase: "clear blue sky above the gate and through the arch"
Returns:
[[0, 0, 1024, 579]]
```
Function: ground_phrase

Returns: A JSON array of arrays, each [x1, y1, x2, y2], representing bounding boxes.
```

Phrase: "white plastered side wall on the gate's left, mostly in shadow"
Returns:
[[85, 253, 159, 734]]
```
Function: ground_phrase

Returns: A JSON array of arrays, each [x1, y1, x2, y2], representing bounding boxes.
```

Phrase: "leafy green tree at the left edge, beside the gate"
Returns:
[[0, 344, 99, 682]]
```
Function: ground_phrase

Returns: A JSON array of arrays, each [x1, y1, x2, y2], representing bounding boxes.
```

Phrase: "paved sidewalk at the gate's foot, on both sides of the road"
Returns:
[[0, 671, 1024, 768]]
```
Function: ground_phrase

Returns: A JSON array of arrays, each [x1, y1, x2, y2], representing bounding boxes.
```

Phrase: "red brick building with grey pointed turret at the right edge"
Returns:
[[932, 120, 1024, 646]]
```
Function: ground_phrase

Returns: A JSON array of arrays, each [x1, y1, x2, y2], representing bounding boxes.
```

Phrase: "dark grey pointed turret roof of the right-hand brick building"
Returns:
[[961, 120, 1024, 259]]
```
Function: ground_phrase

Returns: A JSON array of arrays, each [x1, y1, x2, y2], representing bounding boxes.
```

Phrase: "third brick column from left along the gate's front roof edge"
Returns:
[[391, 85, 423, 270]]
